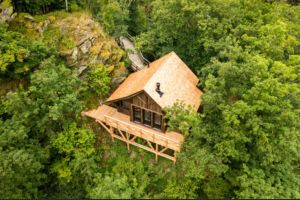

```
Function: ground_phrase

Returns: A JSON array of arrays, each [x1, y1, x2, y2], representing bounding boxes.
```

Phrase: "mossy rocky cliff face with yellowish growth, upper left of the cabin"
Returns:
[[11, 11, 127, 84]]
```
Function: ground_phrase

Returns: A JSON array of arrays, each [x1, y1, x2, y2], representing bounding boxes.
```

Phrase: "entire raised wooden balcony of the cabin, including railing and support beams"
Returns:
[[82, 105, 184, 163]]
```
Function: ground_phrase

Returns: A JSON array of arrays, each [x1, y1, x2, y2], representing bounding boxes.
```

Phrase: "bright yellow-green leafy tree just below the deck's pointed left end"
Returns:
[[51, 123, 96, 184]]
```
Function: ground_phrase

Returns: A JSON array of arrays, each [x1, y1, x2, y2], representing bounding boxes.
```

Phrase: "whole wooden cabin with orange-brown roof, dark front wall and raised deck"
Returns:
[[82, 52, 202, 162]]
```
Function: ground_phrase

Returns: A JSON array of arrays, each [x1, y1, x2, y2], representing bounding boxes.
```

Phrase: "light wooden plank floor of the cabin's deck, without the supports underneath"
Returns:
[[82, 105, 184, 152]]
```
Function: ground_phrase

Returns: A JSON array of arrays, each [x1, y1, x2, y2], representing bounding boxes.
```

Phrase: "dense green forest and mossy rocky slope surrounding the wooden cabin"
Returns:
[[0, 0, 300, 199]]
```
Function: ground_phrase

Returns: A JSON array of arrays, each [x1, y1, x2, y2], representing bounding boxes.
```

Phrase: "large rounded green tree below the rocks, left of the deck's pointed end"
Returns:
[[1, 57, 82, 132]]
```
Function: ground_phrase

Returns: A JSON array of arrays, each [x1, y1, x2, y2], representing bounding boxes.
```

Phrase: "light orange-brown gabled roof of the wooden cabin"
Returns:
[[106, 52, 202, 110]]
